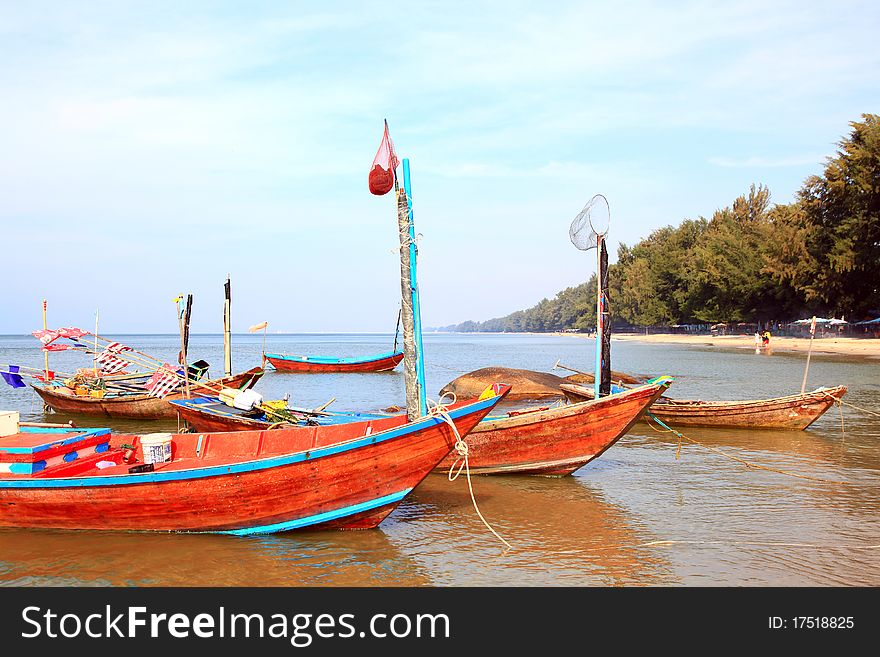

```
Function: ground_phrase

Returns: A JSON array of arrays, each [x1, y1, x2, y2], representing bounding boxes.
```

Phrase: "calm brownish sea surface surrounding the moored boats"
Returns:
[[0, 334, 880, 586]]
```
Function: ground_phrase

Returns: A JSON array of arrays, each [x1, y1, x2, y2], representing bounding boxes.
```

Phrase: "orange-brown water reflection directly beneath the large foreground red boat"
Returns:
[[0, 530, 429, 586]]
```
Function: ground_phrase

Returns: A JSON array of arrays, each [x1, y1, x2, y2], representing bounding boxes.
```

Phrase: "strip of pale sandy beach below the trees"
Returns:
[[596, 333, 880, 359]]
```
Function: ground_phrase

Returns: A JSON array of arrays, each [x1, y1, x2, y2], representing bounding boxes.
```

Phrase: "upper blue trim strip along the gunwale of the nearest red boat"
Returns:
[[0, 397, 498, 490]]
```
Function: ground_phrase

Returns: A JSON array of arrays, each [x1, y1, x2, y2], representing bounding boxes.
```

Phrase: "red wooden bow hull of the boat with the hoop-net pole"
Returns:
[[438, 377, 672, 476]]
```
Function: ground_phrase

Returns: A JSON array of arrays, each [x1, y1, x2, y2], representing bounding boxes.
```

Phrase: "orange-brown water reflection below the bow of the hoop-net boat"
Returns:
[[393, 475, 670, 585]]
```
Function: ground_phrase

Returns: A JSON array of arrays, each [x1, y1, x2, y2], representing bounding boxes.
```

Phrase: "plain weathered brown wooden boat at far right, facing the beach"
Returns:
[[560, 384, 846, 429]]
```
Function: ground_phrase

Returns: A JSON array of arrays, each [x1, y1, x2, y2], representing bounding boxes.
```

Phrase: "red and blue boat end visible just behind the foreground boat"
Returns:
[[171, 397, 392, 431]]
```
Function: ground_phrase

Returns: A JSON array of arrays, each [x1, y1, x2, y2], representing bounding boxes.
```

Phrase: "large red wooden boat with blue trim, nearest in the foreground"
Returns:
[[0, 386, 509, 535]]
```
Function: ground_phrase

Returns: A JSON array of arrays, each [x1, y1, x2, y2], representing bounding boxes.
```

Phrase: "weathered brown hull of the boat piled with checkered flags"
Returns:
[[32, 367, 263, 420]]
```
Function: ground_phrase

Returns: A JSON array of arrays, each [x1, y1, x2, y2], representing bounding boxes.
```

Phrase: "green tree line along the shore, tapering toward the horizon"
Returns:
[[444, 114, 880, 332]]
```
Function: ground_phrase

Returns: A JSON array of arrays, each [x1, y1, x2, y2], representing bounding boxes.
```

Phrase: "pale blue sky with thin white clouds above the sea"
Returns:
[[0, 0, 880, 333]]
